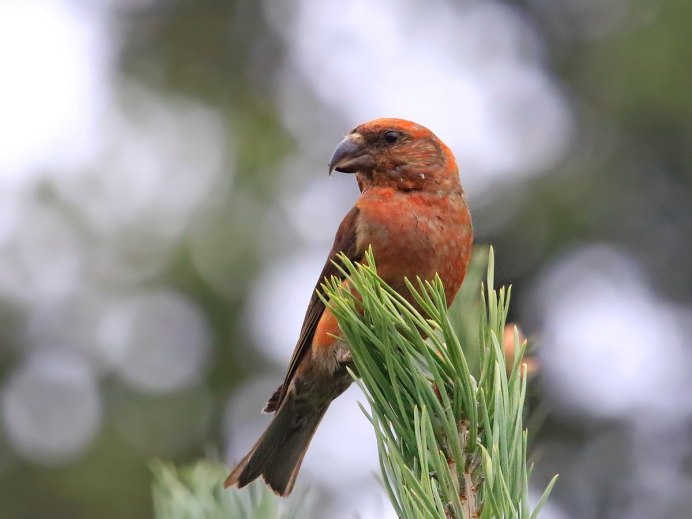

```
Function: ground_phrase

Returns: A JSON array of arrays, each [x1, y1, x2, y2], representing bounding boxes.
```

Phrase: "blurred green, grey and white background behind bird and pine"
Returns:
[[0, 0, 692, 519]]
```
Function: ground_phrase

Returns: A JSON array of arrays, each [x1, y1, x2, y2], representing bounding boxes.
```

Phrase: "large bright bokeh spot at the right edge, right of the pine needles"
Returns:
[[537, 245, 689, 417]]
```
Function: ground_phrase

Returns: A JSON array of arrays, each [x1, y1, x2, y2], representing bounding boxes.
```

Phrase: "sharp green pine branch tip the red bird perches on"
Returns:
[[324, 246, 555, 519]]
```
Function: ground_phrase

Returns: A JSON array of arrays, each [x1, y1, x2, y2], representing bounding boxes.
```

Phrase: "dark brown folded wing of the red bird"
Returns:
[[264, 206, 363, 413]]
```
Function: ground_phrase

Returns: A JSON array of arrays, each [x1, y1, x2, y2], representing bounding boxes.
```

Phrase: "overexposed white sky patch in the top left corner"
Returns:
[[0, 0, 112, 184]]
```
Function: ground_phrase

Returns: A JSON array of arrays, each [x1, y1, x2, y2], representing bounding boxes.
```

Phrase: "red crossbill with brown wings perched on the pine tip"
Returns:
[[224, 118, 473, 496]]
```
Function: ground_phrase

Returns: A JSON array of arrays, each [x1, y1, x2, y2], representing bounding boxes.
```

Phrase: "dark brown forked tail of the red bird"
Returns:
[[224, 391, 329, 496]]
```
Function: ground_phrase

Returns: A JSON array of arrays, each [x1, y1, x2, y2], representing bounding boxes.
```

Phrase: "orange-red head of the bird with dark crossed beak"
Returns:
[[329, 119, 459, 191]]
